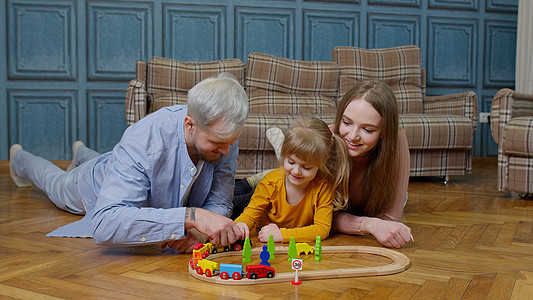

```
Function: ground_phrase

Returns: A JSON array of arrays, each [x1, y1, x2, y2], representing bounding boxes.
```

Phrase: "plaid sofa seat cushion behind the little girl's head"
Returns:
[[239, 113, 335, 151]]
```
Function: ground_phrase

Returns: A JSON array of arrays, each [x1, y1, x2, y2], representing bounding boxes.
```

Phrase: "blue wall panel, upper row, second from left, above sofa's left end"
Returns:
[[87, 2, 153, 80]]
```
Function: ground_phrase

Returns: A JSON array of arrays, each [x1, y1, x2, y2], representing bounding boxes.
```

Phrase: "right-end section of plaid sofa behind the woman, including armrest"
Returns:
[[332, 46, 478, 180]]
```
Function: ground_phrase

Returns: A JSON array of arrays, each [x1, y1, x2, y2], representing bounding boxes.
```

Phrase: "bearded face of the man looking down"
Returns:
[[185, 119, 241, 163]]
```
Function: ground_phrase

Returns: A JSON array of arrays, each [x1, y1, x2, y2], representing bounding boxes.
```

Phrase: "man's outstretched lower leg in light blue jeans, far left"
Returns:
[[10, 145, 85, 214]]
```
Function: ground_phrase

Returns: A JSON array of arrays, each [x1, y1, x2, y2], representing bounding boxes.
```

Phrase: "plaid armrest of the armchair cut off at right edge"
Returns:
[[490, 89, 533, 144]]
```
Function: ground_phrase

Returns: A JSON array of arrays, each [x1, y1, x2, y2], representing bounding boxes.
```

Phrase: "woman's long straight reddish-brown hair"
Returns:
[[334, 80, 398, 217]]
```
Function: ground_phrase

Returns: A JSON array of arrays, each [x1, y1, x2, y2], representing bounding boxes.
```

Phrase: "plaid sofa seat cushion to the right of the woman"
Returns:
[[399, 114, 472, 149]]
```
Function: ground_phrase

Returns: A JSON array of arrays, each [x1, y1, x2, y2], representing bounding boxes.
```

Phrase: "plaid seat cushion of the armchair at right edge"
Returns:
[[502, 116, 533, 157]]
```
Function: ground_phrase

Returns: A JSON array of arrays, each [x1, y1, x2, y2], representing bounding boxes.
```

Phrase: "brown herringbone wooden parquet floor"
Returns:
[[0, 158, 533, 299]]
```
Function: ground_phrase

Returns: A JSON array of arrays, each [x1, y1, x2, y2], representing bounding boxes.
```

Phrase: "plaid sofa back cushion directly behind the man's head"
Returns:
[[146, 57, 244, 112]]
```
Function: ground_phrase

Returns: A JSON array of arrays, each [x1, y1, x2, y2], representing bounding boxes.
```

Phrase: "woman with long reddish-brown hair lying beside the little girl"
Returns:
[[332, 81, 411, 248]]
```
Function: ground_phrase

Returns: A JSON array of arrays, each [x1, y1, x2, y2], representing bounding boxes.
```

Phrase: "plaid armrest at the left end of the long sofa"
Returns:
[[124, 79, 149, 126]]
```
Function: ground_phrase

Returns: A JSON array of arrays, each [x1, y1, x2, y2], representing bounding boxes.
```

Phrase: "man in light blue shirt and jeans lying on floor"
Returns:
[[10, 73, 248, 252]]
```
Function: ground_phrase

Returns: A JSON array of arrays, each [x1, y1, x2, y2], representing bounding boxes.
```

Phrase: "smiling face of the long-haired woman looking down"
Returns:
[[339, 99, 382, 158]]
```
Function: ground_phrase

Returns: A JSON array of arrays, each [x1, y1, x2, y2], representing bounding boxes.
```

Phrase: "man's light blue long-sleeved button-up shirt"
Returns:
[[45, 105, 238, 244]]
